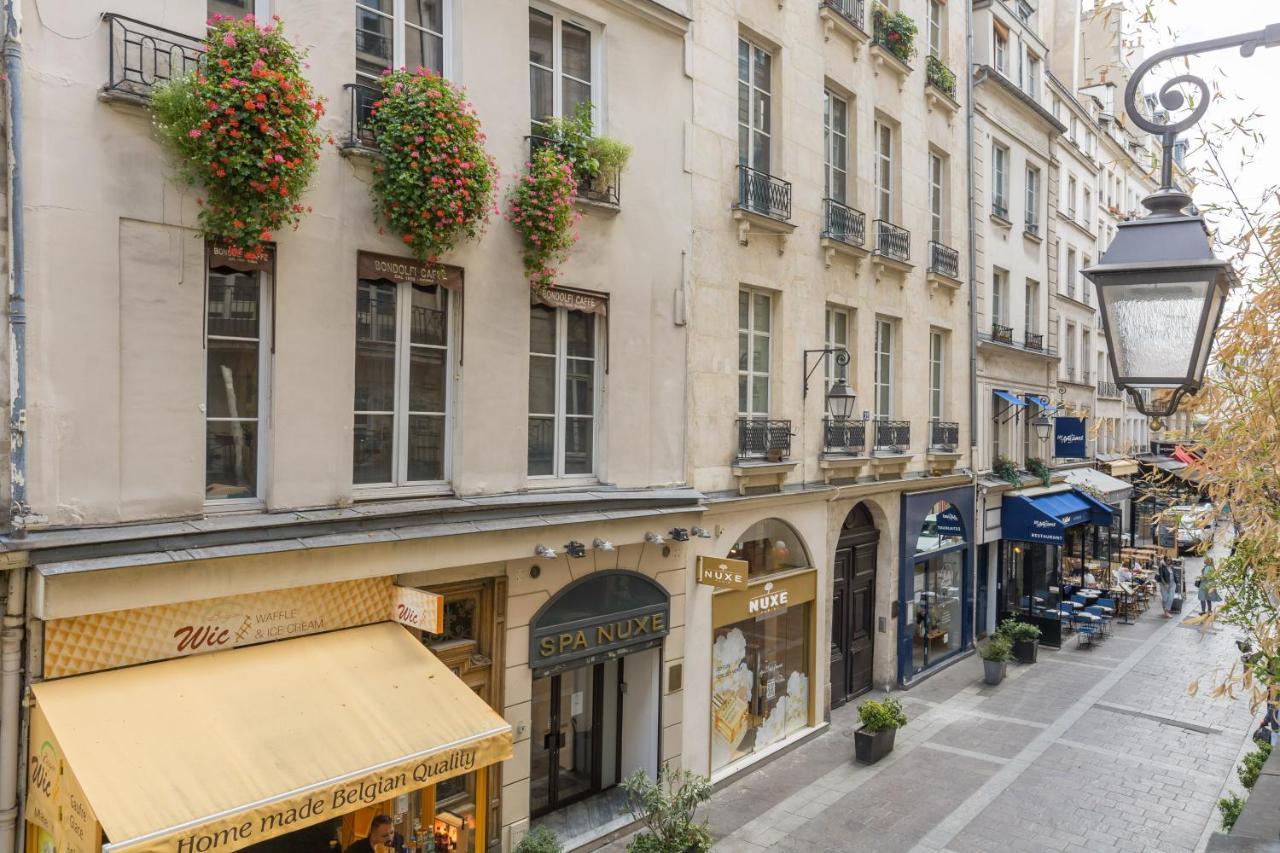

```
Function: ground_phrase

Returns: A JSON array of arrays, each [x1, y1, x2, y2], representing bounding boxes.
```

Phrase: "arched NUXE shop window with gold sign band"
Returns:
[[710, 519, 818, 779]]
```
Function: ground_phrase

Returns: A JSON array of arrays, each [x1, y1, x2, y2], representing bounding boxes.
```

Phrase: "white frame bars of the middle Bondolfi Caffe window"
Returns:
[[352, 282, 462, 497]]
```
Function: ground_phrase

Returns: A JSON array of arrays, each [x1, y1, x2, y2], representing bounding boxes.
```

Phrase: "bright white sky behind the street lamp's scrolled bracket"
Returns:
[[1121, 0, 1280, 280]]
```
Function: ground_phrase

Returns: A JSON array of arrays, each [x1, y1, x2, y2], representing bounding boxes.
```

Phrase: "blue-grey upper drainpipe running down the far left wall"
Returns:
[[0, 0, 31, 532]]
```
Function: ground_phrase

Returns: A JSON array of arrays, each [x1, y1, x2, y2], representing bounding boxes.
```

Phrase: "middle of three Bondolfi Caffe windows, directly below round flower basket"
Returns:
[[352, 279, 453, 485]]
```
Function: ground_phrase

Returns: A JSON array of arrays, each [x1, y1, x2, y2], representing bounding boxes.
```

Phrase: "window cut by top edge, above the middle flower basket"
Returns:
[[356, 0, 448, 85]]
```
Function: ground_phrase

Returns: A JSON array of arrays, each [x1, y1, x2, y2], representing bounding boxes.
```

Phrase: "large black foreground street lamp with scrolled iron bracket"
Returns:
[[1082, 24, 1280, 418]]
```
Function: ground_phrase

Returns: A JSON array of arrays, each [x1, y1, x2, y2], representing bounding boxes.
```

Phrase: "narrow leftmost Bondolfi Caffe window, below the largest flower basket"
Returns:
[[205, 270, 271, 501]]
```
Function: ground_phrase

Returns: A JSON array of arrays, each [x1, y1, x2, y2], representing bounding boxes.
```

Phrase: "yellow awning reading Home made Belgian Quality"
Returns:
[[27, 622, 511, 853]]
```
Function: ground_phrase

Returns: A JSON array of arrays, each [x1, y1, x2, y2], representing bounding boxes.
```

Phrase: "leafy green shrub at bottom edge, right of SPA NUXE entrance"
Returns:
[[622, 767, 712, 853]]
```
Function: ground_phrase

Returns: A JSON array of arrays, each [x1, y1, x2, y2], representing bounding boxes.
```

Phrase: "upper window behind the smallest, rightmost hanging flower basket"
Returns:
[[527, 0, 600, 136]]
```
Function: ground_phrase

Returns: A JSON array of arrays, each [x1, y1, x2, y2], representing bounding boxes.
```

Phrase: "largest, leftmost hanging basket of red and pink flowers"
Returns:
[[151, 15, 324, 260]]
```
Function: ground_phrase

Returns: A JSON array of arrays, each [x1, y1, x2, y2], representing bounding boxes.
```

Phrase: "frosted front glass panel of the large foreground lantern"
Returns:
[[1098, 278, 1216, 387]]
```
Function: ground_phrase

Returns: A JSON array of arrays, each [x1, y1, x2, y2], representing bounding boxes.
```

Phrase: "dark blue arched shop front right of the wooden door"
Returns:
[[897, 485, 974, 684]]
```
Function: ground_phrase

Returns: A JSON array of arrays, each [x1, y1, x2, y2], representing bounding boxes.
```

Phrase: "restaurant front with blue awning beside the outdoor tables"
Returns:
[[998, 488, 1112, 646]]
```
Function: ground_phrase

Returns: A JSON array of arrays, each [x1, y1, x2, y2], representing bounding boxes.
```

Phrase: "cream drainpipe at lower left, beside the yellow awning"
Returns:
[[0, 569, 27, 853]]
